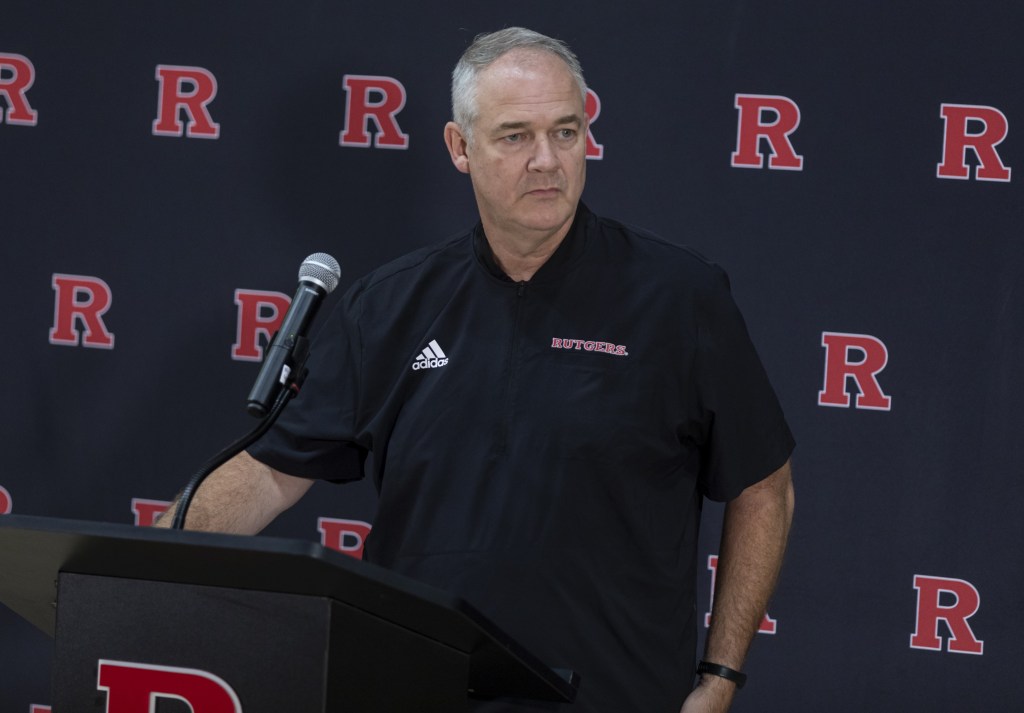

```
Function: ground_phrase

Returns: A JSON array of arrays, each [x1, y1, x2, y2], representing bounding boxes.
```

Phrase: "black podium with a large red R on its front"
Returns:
[[0, 515, 578, 713]]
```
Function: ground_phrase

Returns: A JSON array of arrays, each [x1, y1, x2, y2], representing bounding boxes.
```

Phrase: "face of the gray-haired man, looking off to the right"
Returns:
[[450, 50, 587, 241]]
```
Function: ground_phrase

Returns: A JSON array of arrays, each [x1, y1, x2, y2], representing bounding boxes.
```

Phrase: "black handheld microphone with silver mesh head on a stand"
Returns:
[[246, 253, 341, 418]]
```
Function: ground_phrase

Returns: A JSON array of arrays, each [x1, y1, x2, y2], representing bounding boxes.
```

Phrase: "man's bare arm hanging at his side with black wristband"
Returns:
[[681, 462, 794, 713]]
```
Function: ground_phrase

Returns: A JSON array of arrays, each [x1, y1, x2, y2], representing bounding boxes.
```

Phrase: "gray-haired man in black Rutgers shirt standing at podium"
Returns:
[[157, 28, 793, 713]]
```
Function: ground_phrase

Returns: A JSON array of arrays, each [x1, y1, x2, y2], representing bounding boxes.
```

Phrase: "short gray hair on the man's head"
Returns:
[[452, 28, 587, 143]]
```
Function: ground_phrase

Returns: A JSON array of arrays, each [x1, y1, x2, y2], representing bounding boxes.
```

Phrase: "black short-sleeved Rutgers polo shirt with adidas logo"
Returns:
[[250, 204, 794, 713]]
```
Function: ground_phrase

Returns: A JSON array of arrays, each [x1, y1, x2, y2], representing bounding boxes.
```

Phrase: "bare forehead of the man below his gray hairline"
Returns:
[[476, 50, 584, 123]]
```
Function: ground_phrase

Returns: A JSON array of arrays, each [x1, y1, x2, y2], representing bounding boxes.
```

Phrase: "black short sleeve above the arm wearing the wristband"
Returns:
[[695, 267, 796, 501]]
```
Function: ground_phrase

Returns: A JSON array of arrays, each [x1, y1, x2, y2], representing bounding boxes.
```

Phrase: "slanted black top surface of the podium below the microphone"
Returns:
[[0, 515, 578, 701]]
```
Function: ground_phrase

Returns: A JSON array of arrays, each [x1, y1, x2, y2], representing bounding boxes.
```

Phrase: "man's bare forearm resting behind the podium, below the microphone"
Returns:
[[155, 451, 313, 535]]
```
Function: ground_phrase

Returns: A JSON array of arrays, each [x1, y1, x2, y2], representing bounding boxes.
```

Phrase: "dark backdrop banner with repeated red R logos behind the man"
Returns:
[[0, 0, 1024, 713]]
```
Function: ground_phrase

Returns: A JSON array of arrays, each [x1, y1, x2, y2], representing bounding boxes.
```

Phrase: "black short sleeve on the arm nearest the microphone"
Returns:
[[248, 287, 369, 483]]
